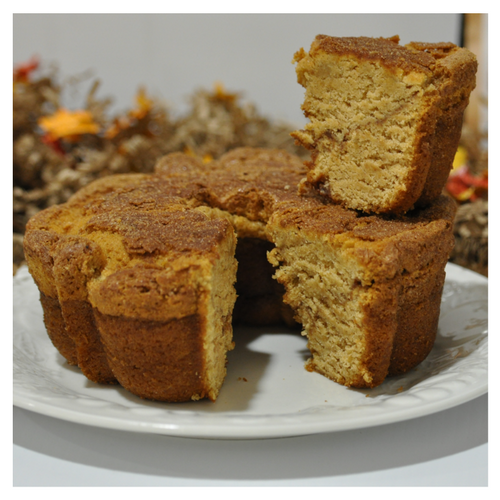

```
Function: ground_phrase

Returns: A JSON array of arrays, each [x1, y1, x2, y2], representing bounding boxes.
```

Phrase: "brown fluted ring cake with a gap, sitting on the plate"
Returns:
[[25, 148, 454, 401]]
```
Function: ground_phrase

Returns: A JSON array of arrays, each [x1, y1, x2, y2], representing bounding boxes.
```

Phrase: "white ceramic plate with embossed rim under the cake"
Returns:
[[14, 264, 488, 439]]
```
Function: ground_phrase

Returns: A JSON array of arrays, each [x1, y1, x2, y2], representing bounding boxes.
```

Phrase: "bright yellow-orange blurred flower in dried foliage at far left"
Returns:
[[38, 108, 99, 141]]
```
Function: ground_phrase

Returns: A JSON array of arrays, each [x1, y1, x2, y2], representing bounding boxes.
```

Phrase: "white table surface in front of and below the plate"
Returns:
[[13, 394, 488, 486]]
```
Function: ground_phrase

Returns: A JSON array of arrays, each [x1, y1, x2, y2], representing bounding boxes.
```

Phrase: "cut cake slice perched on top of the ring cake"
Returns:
[[292, 35, 477, 214]]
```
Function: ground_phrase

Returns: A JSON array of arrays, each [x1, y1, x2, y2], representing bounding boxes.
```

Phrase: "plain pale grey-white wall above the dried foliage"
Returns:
[[13, 14, 460, 125]]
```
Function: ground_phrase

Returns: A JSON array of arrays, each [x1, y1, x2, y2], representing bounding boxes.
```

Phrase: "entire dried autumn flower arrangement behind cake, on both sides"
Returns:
[[13, 58, 488, 275]]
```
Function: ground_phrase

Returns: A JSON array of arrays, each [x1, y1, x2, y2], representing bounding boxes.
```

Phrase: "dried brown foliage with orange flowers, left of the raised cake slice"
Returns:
[[13, 58, 305, 265]]
